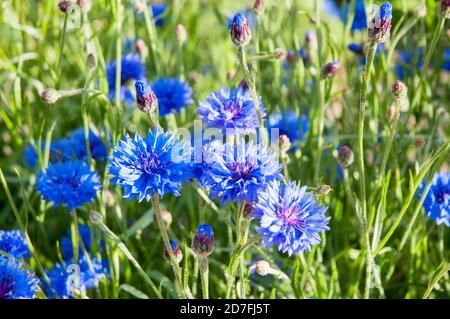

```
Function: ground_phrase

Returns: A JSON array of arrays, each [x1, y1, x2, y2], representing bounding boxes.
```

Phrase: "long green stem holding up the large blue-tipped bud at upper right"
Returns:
[[358, 43, 377, 298]]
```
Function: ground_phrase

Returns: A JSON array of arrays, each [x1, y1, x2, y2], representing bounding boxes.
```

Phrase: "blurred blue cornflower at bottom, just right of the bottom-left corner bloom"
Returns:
[[43, 256, 109, 299]]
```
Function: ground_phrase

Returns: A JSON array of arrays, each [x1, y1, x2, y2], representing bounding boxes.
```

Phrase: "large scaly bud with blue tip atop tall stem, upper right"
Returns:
[[367, 2, 392, 43]]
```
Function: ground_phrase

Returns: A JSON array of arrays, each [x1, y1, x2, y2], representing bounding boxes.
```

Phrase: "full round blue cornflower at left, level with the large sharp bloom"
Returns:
[[36, 161, 101, 210]]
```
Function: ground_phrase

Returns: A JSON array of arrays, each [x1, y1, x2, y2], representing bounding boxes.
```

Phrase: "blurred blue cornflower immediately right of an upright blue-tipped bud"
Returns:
[[152, 78, 194, 116]]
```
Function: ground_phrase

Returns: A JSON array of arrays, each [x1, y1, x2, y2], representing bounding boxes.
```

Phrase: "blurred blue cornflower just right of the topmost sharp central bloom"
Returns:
[[267, 110, 309, 149]]
